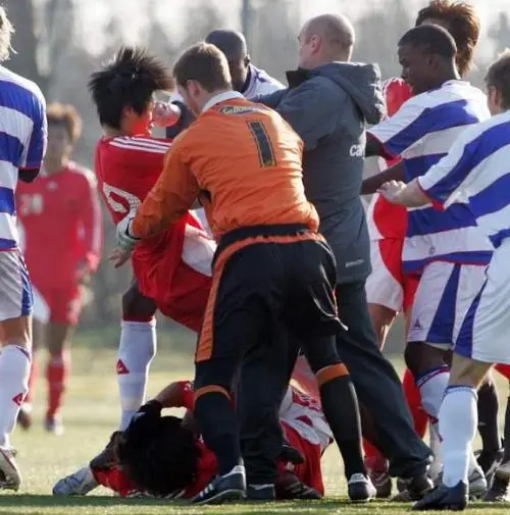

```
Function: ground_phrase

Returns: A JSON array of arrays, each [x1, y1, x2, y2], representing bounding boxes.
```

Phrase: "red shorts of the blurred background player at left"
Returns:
[[36, 284, 82, 325]]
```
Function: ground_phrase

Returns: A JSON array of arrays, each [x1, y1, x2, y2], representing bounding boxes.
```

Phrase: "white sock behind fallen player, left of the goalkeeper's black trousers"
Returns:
[[117, 320, 156, 431]]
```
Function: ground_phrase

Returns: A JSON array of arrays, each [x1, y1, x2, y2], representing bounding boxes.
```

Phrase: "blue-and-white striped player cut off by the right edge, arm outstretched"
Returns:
[[382, 51, 510, 509]]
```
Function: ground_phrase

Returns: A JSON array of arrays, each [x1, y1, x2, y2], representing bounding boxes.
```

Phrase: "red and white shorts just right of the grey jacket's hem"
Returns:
[[366, 238, 420, 313]]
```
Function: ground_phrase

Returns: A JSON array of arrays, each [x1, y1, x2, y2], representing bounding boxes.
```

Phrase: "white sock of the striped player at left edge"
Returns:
[[0, 345, 31, 447]]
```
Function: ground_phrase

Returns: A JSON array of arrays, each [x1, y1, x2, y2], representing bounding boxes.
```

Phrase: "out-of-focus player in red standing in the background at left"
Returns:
[[16, 104, 102, 434]]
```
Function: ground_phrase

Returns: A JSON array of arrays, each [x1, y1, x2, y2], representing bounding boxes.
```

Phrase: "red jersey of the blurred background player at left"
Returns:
[[16, 163, 103, 288]]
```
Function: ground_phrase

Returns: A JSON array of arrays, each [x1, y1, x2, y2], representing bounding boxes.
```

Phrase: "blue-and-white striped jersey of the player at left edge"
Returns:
[[0, 66, 47, 251]]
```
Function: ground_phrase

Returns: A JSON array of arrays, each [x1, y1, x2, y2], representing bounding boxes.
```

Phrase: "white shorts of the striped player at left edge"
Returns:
[[0, 249, 34, 322]]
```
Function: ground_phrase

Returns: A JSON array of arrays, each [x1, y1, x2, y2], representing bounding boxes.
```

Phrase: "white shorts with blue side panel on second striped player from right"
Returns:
[[407, 261, 487, 350]]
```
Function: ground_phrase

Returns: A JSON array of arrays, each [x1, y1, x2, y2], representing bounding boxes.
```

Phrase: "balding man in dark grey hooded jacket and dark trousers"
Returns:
[[255, 15, 431, 497]]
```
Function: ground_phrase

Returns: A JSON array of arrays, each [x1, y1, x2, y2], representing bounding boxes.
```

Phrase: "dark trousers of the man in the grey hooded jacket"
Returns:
[[336, 281, 430, 477]]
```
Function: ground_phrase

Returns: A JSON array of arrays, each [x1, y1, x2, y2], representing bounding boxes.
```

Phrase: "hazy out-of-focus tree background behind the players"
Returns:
[[3, 0, 510, 350]]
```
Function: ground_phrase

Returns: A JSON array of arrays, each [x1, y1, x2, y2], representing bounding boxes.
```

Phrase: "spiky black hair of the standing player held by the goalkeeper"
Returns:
[[88, 47, 175, 129]]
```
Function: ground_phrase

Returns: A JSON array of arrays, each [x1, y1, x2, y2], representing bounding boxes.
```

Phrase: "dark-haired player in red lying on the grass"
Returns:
[[53, 381, 332, 499]]
